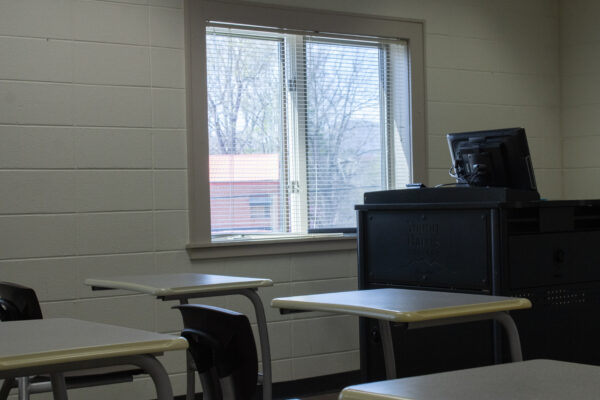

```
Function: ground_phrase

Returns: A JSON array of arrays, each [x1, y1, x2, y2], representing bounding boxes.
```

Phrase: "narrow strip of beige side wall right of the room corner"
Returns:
[[560, 0, 600, 199]]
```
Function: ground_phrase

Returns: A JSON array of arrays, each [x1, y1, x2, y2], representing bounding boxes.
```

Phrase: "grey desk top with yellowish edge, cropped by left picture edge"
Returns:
[[0, 318, 188, 371]]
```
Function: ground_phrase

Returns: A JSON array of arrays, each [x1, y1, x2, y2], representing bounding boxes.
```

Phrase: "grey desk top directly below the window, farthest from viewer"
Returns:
[[84, 273, 273, 297]]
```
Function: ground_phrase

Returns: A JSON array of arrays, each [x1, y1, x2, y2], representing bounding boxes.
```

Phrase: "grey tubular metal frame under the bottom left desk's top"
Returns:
[[0, 354, 173, 400]]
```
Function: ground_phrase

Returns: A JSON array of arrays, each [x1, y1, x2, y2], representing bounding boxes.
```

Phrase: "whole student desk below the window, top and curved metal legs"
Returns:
[[84, 273, 273, 400]]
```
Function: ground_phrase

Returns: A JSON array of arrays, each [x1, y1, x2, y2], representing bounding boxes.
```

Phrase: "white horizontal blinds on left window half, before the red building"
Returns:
[[206, 27, 286, 235]]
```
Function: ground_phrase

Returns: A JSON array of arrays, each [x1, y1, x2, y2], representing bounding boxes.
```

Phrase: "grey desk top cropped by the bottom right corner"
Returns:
[[339, 360, 600, 400]]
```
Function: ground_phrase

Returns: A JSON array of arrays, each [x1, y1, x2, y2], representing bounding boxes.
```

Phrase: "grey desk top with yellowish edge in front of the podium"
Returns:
[[271, 289, 531, 322]]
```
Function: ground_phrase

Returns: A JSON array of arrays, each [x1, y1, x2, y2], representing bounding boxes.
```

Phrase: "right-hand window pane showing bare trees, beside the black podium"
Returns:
[[306, 41, 386, 230]]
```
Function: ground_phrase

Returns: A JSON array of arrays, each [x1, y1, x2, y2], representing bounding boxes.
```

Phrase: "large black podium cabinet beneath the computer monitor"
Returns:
[[356, 187, 600, 380]]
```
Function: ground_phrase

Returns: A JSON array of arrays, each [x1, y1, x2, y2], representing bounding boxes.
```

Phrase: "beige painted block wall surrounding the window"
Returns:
[[0, 0, 564, 399]]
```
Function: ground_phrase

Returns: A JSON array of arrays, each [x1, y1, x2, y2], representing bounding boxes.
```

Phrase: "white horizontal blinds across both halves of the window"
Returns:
[[207, 25, 411, 236]]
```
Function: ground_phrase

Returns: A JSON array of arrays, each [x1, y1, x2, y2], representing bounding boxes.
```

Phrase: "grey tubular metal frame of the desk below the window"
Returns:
[[158, 288, 273, 400]]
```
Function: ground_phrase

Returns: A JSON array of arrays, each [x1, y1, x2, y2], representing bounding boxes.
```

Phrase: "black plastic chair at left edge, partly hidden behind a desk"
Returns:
[[0, 282, 143, 400]]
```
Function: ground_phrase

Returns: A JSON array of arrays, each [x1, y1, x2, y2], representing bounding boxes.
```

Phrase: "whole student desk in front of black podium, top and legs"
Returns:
[[271, 289, 531, 379]]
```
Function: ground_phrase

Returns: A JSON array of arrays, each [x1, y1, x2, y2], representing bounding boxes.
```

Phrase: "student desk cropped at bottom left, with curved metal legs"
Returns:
[[0, 318, 188, 400]]
